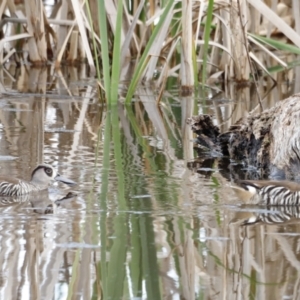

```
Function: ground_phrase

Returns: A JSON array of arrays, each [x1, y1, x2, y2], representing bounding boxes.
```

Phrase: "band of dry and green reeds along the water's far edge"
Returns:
[[0, 0, 300, 104]]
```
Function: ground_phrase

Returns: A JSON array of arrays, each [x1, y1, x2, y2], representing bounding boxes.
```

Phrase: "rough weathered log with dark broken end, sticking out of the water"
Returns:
[[187, 93, 300, 181]]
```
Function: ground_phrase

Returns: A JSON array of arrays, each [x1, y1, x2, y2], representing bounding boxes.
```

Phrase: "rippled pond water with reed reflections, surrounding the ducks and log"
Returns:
[[0, 67, 300, 300]]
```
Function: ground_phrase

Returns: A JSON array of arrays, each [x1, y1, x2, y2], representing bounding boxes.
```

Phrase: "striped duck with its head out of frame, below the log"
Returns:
[[237, 180, 300, 206]]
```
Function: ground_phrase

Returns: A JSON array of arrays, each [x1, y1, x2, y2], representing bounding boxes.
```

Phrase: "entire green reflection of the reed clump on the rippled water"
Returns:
[[93, 97, 190, 299]]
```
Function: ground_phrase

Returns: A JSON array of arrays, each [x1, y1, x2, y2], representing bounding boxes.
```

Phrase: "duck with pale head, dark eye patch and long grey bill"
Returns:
[[0, 164, 75, 196]]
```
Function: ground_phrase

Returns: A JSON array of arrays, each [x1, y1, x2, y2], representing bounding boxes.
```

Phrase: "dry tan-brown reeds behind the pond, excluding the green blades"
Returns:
[[0, 0, 300, 94]]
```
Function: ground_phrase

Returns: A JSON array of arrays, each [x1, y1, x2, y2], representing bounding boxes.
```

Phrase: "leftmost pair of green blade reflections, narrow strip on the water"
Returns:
[[100, 106, 128, 299]]
